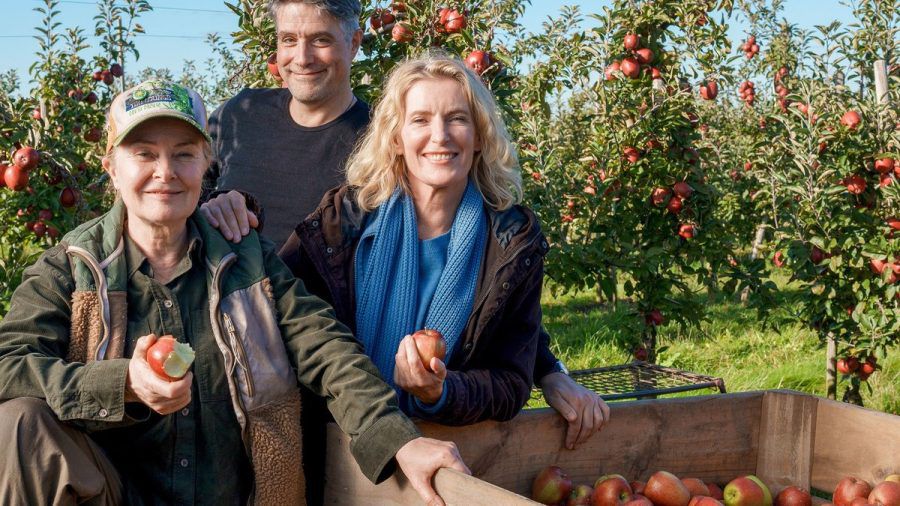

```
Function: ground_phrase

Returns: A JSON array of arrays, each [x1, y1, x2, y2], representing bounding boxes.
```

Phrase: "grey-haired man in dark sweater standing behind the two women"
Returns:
[[201, 0, 609, 472]]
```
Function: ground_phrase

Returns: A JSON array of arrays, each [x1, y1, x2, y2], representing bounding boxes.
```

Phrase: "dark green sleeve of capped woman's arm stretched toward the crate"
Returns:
[[264, 240, 419, 483]]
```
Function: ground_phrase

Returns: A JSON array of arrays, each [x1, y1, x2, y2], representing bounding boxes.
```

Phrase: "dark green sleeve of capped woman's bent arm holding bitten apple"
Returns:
[[0, 245, 133, 430]]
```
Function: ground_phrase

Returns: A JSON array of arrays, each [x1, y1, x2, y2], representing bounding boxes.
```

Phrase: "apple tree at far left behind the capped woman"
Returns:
[[0, 0, 150, 314]]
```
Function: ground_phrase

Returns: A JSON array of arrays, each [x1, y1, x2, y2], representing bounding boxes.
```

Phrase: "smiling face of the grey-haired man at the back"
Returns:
[[275, 3, 362, 105]]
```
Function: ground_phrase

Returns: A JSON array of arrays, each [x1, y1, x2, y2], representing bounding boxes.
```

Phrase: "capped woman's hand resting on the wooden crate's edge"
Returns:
[[396, 437, 472, 506]]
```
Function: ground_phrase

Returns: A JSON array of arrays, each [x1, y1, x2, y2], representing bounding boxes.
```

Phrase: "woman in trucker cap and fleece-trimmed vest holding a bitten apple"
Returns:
[[0, 81, 467, 504]]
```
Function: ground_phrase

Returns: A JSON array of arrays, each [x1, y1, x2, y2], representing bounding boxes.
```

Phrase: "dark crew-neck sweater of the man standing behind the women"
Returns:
[[203, 88, 369, 247]]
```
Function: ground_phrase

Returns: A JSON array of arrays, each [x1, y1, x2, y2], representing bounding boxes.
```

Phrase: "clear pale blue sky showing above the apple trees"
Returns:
[[0, 0, 850, 89]]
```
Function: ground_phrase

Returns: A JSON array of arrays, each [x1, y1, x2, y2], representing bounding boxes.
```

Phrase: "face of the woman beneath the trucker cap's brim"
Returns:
[[103, 118, 209, 226]]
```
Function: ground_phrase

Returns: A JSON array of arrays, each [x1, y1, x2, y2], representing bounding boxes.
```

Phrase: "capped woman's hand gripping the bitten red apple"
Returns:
[[125, 334, 194, 415]]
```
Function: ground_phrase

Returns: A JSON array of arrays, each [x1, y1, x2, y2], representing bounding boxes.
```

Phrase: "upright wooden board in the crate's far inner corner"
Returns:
[[756, 390, 818, 495]]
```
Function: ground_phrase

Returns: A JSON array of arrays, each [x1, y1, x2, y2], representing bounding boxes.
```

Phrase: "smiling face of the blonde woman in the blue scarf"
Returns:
[[397, 79, 481, 198]]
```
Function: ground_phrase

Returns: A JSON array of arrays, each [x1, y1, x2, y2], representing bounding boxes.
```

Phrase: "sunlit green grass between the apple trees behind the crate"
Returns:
[[536, 280, 900, 414]]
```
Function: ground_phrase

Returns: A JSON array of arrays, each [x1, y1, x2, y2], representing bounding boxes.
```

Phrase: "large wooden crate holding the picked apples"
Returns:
[[325, 390, 900, 506]]
